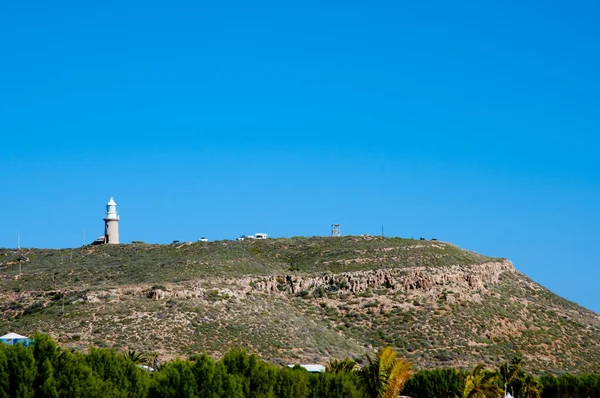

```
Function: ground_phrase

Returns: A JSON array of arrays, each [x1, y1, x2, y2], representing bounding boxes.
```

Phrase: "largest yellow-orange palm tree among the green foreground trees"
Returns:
[[359, 347, 412, 398]]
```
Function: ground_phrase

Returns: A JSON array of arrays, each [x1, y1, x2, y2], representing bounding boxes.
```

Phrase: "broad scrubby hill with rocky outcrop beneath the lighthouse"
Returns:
[[0, 236, 600, 373]]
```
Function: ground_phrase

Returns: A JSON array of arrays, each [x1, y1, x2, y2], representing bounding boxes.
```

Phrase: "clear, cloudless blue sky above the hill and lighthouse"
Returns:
[[0, 0, 600, 311]]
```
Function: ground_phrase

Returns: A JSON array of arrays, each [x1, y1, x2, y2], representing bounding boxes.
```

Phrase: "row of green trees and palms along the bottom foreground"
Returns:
[[0, 335, 600, 398]]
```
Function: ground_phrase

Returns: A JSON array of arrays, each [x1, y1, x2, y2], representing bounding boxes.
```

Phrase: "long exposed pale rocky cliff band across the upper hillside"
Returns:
[[147, 260, 517, 300]]
